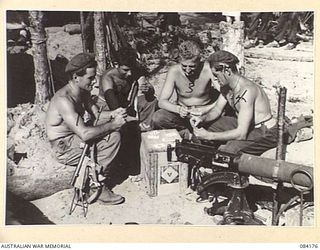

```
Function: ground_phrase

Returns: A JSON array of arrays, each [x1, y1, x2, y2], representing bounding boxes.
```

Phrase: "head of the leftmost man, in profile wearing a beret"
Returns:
[[65, 53, 97, 91]]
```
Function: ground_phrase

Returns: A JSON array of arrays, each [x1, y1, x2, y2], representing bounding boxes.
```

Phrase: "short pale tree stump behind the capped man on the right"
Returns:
[[219, 21, 244, 67]]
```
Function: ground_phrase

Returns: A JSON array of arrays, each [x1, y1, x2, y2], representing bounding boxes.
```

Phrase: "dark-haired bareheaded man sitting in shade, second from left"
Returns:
[[97, 48, 157, 130]]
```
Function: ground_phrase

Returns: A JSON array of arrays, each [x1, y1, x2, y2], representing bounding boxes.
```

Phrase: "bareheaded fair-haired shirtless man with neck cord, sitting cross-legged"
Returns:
[[152, 41, 220, 137]]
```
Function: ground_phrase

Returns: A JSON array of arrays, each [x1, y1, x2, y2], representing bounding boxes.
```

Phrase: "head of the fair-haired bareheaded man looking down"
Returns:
[[179, 40, 200, 76]]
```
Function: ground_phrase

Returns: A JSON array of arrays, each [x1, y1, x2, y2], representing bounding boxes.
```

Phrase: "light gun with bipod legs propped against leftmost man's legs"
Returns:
[[69, 107, 105, 217]]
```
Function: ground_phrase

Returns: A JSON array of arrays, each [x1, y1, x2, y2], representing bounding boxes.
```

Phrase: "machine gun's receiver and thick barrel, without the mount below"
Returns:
[[175, 140, 313, 189]]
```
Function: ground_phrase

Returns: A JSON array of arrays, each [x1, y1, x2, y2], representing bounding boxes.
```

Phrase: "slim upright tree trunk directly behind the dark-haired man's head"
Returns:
[[94, 12, 106, 79]]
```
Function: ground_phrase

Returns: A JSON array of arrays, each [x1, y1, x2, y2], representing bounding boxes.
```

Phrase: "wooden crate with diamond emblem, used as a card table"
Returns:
[[140, 129, 188, 197]]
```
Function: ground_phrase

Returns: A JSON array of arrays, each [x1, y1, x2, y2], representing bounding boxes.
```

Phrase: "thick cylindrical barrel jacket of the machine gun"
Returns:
[[238, 154, 313, 187]]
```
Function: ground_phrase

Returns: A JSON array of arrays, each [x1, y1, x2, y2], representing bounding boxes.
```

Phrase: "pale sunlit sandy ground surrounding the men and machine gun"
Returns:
[[7, 16, 314, 225]]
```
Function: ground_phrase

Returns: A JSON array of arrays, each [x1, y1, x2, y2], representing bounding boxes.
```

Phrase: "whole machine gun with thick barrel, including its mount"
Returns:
[[167, 140, 313, 225]]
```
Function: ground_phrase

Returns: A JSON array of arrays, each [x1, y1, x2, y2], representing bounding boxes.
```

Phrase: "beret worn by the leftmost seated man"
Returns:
[[65, 53, 96, 73]]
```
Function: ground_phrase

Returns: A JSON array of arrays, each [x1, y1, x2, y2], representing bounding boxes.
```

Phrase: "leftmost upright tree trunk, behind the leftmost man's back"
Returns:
[[29, 11, 52, 104]]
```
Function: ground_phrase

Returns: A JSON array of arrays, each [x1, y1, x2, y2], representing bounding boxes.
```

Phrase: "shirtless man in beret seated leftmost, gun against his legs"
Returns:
[[46, 53, 126, 204]]
